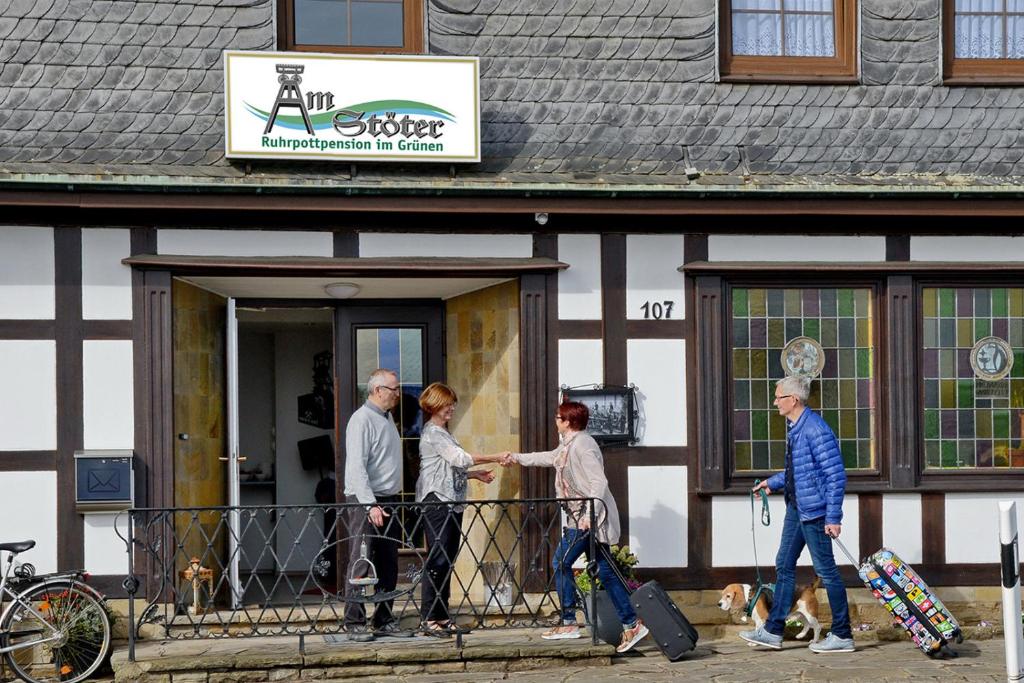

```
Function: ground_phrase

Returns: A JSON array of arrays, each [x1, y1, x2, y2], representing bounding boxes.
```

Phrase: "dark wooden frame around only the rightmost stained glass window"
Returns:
[[913, 275, 1024, 490]]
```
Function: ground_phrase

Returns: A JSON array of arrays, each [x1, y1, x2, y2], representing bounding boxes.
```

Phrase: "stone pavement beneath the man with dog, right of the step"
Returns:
[[385, 639, 1007, 683]]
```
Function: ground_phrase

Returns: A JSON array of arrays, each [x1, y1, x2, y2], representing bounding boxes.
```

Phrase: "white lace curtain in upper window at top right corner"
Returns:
[[953, 0, 1024, 59]]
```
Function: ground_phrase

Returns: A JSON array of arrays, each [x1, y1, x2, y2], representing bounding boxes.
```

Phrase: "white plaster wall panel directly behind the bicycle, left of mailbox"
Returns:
[[0, 472, 57, 573]]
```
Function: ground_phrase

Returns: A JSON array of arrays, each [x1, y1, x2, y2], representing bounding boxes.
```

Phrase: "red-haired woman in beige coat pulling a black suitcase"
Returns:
[[504, 401, 647, 652]]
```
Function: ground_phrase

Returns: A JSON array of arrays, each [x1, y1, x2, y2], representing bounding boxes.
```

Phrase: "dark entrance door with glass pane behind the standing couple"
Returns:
[[335, 301, 444, 547]]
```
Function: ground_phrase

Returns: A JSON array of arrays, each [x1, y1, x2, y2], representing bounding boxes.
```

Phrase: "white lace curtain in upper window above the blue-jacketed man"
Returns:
[[732, 0, 835, 57]]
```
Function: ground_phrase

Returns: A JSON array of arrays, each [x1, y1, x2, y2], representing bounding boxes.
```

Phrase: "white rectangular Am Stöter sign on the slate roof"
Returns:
[[224, 50, 480, 162]]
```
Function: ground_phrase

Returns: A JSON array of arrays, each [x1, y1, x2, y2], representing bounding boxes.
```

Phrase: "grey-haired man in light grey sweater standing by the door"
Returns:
[[345, 369, 412, 641]]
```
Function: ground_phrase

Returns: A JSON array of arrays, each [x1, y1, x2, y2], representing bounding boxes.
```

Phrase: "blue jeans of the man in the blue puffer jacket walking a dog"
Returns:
[[765, 504, 853, 638]]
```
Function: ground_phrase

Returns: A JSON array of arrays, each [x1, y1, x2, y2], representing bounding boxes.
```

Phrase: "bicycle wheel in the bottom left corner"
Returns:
[[0, 581, 111, 683]]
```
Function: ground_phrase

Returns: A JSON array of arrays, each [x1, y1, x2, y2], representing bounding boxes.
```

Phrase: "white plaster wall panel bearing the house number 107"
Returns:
[[626, 234, 686, 321]]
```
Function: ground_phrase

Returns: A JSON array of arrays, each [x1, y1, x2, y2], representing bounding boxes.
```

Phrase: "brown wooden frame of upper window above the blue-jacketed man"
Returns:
[[719, 0, 857, 83]]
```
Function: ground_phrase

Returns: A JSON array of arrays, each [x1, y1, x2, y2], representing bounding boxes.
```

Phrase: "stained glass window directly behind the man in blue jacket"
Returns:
[[732, 288, 876, 472]]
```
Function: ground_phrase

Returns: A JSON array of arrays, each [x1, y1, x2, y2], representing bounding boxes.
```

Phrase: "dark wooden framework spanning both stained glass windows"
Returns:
[[681, 261, 1024, 496]]
